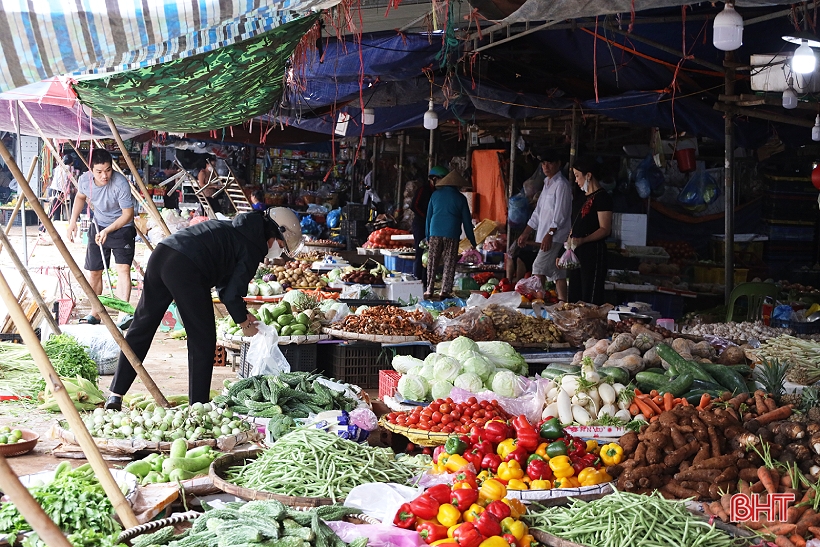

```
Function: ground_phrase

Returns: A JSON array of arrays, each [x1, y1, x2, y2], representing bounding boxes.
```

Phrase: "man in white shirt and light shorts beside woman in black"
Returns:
[[518, 151, 572, 302]]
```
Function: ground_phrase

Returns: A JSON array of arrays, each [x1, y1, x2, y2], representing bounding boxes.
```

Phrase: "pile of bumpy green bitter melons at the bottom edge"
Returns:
[[131, 500, 367, 547]]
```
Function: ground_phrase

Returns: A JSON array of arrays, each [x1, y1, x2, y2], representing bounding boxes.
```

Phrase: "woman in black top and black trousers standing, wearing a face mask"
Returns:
[[569, 159, 612, 305]]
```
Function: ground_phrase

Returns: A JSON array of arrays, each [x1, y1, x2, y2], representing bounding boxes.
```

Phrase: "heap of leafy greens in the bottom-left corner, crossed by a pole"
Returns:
[[0, 462, 122, 547]]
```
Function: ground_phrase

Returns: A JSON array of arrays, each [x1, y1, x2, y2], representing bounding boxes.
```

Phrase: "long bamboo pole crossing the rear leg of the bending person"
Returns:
[[0, 141, 169, 408]]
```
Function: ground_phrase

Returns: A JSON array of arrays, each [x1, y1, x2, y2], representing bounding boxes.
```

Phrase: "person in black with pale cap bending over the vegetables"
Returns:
[[105, 212, 302, 410]]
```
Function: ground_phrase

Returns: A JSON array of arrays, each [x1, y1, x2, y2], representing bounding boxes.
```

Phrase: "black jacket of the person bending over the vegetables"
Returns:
[[160, 212, 268, 323]]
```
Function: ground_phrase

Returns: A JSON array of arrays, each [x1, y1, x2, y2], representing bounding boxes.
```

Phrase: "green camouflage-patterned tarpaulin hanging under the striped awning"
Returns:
[[74, 14, 320, 132]]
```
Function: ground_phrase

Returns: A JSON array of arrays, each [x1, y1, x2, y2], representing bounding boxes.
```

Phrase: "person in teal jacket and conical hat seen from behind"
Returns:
[[424, 171, 476, 300]]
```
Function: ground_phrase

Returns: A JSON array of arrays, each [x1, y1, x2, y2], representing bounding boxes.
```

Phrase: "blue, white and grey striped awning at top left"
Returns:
[[0, 0, 338, 92]]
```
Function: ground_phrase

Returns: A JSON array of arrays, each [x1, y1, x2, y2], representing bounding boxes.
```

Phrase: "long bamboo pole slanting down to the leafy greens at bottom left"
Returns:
[[0, 268, 139, 528]]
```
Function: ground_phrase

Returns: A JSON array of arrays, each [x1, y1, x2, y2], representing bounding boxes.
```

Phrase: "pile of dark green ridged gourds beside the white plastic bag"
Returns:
[[213, 372, 358, 418]]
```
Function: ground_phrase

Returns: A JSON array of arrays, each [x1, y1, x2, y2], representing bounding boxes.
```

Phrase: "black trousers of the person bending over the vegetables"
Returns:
[[111, 244, 216, 404]]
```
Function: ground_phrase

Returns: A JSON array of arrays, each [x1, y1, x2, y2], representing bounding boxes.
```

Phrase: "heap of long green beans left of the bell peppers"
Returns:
[[226, 428, 418, 503]]
